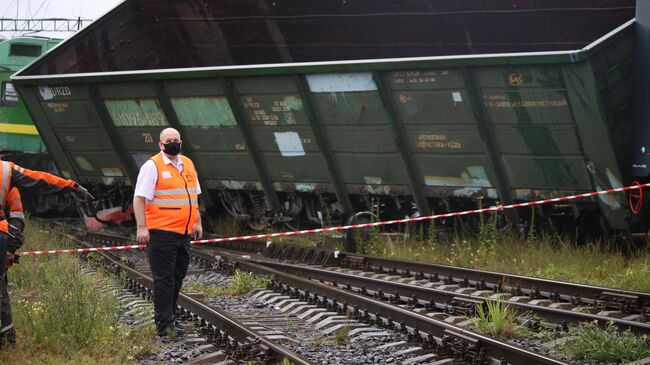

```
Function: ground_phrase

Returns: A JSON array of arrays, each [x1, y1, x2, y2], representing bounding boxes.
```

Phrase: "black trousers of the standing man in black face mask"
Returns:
[[147, 229, 190, 330]]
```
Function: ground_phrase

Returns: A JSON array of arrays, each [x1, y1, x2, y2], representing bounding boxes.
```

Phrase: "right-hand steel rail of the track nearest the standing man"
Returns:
[[193, 247, 567, 365]]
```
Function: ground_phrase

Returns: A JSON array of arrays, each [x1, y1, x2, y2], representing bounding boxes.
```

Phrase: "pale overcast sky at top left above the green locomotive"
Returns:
[[0, 0, 123, 38]]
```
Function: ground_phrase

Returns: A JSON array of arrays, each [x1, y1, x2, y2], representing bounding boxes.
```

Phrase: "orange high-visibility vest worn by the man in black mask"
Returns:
[[145, 153, 199, 234]]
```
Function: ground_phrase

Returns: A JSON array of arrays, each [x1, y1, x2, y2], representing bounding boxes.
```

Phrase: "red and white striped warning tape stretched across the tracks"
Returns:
[[18, 183, 650, 256]]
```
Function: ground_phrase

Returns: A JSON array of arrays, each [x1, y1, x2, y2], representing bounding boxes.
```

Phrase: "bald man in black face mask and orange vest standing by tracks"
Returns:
[[133, 128, 203, 336]]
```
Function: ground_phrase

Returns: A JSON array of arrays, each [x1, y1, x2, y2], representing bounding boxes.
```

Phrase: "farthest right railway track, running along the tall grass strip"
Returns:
[[216, 242, 650, 334]]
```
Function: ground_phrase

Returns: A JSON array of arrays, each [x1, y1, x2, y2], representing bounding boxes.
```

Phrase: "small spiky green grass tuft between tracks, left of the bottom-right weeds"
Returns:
[[470, 300, 527, 337]]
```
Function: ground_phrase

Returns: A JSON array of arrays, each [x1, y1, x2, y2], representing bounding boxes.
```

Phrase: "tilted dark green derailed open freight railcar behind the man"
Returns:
[[8, 0, 635, 237]]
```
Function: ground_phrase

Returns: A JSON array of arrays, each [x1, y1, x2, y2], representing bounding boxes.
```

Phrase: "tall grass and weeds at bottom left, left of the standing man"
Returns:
[[0, 221, 154, 364]]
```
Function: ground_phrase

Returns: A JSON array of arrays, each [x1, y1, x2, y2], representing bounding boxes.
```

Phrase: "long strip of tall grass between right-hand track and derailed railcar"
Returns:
[[358, 223, 650, 292]]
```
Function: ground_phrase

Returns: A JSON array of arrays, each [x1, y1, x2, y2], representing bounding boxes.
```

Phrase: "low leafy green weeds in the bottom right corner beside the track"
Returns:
[[561, 322, 650, 363]]
